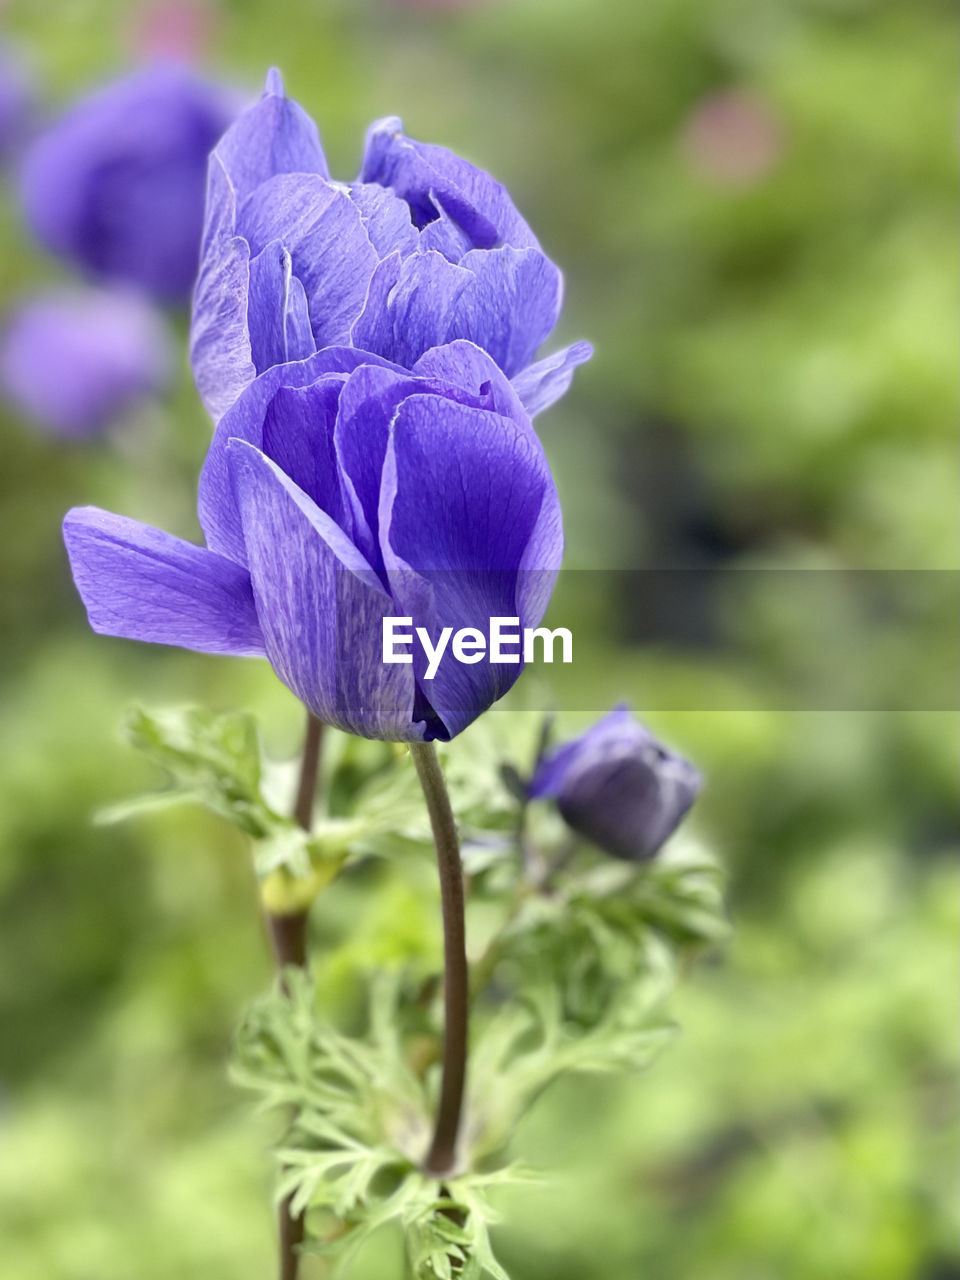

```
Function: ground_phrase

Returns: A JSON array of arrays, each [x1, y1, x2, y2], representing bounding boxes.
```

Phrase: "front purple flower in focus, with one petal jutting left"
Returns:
[[64, 342, 562, 740]]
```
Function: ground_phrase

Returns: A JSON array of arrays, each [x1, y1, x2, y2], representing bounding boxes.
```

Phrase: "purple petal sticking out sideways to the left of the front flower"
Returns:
[[63, 507, 265, 657]]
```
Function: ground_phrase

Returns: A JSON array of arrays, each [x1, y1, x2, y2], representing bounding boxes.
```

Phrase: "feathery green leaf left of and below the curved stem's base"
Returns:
[[232, 972, 529, 1280]]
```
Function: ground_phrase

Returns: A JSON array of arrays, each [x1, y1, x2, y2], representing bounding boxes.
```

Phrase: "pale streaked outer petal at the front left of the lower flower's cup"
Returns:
[[229, 440, 422, 741]]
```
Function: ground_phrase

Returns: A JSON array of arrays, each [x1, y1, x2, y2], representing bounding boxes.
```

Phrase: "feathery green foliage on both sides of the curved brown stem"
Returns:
[[233, 793, 726, 1280]]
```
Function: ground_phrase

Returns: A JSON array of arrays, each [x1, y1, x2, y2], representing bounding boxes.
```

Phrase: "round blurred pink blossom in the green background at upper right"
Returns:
[[682, 90, 783, 187]]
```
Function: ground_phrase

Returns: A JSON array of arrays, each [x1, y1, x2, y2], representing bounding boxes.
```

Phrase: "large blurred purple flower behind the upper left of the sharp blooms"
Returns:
[[22, 65, 236, 302]]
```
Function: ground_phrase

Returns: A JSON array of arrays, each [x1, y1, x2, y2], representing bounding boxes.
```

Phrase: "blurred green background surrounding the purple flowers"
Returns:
[[0, 0, 960, 1280]]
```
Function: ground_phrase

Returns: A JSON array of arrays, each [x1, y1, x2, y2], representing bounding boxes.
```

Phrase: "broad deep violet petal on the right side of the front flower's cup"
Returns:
[[380, 394, 562, 736]]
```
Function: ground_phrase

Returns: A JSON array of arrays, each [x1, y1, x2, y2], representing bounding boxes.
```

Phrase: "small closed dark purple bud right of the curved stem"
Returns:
[[529, 707, 703, 863]]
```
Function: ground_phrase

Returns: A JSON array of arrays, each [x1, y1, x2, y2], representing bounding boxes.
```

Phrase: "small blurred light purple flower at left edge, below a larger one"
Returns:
[[0, 289, 170, 436]]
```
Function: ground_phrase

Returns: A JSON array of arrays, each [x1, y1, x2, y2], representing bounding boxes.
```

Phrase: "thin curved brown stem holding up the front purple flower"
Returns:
[[410, 742, 470, 1175]]
